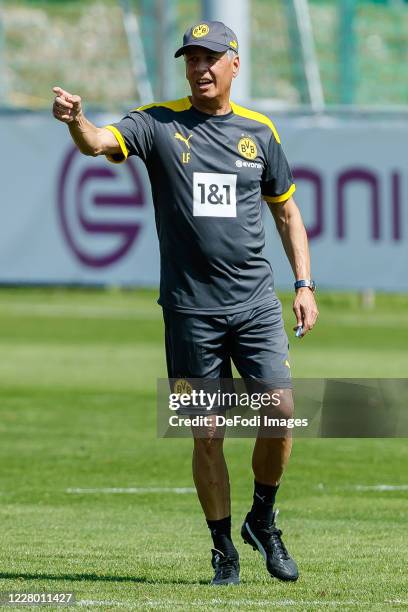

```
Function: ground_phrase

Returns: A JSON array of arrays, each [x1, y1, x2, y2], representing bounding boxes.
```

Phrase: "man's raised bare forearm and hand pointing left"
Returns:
[[52, 87, 122, 157]]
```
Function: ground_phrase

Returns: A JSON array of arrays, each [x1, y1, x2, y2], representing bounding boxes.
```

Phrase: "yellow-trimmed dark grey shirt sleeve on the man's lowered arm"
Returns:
[[261, 134, 296, 203]]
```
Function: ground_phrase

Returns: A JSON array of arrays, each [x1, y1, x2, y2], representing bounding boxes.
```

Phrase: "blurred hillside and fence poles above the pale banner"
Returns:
[[0, 0, 408, 111]]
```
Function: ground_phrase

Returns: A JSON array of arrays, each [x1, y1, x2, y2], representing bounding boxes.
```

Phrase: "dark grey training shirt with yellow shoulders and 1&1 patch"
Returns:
[[107, 98, 295, 314]]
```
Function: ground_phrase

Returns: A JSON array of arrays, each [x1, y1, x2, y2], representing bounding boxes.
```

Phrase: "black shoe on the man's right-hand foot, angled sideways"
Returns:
[[241, 510, 299, 581]]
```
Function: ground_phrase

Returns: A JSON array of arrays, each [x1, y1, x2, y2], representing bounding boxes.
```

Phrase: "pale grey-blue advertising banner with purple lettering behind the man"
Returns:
[[0, 114, 408, 291]]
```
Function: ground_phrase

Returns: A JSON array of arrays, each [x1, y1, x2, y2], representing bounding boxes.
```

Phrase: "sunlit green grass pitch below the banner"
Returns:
[[0, 289, 408, 610]]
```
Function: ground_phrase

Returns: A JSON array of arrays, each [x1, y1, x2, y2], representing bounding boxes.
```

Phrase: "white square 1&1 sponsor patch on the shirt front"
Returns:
[[193, 172, 237, 217]]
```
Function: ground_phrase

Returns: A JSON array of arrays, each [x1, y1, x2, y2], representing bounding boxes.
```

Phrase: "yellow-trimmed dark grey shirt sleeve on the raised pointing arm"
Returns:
[[105, 111, 154, 164]]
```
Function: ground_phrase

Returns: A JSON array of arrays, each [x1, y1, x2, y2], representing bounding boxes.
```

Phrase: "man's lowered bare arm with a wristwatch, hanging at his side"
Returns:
[[267, 197, 319, 336]]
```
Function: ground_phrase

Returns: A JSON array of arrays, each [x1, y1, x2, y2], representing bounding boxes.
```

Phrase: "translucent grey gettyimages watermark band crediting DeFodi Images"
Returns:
[[157, 378, 408, 438]]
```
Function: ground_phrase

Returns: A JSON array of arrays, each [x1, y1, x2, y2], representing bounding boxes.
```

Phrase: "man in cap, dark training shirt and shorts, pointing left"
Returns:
[[53, 21, 318, 584]]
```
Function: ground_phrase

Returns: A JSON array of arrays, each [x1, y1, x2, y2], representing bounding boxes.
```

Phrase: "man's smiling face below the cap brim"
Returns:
[[184, 46, 239, 101]]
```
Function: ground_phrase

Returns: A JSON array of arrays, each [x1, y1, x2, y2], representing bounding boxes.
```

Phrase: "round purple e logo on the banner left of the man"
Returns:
[[58, 147, 146, 268]]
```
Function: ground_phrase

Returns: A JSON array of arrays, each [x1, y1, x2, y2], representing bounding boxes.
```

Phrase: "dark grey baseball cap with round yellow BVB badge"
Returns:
[[174, 21, 238, 57]]
